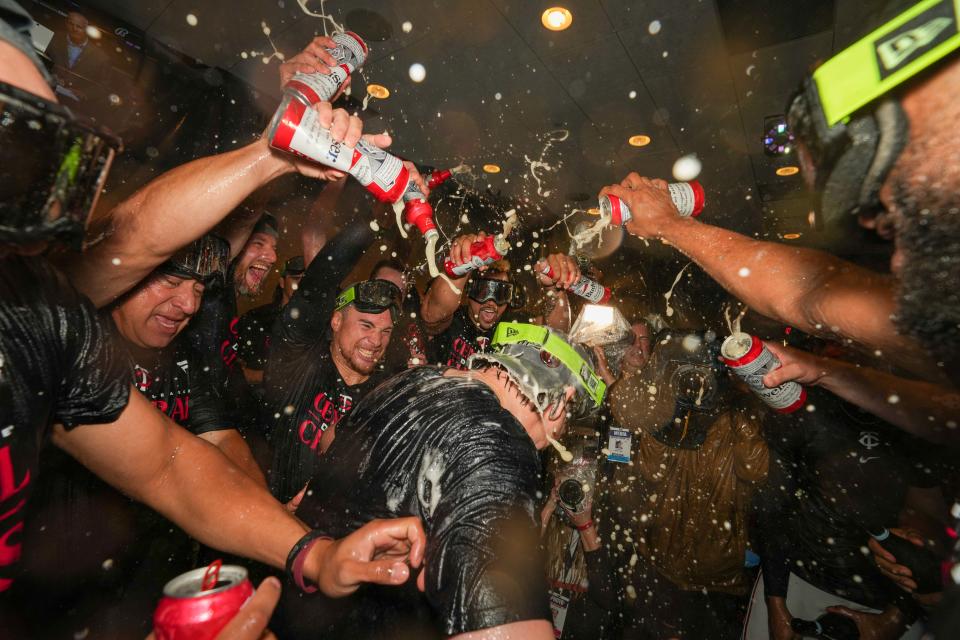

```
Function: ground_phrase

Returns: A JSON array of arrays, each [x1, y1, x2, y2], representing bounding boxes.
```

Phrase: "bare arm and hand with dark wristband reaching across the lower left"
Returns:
[[53, 389, 426, 597]]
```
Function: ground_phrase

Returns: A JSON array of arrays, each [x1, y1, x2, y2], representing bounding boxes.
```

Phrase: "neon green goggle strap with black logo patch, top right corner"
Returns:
[[813, 0, 960, 127]]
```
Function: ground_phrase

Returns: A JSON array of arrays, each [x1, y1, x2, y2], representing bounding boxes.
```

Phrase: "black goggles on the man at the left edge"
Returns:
[[0, 82, 122, 248]]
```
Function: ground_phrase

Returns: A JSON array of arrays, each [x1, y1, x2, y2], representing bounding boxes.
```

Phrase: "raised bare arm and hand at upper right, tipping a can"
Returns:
[[602, 173, 931, 374]]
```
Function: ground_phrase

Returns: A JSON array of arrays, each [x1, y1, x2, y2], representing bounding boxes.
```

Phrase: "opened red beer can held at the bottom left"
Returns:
[[153, 561, 253, 640]]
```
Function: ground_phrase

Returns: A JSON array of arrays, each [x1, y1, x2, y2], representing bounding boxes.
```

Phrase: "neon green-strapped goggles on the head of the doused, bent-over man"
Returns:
[[491, 322, 607, 407]]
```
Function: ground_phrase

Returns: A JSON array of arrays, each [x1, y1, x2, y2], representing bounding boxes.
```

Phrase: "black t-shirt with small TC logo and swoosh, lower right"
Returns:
[[755, 389, 946, 609]]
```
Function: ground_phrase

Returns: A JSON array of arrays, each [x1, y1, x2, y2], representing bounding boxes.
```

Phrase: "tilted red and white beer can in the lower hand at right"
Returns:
[[720, 333, 807, 413]]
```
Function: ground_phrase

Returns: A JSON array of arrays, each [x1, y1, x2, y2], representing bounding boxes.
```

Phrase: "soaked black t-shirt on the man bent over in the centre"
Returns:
[[283, 367, 550, 638]]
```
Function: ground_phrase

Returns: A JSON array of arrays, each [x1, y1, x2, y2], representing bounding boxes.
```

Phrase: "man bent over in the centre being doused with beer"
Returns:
[[277, 322, 606, 640]]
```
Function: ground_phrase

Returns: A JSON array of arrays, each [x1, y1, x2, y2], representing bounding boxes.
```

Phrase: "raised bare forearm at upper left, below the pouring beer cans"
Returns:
[[69, 140, 292, 306]]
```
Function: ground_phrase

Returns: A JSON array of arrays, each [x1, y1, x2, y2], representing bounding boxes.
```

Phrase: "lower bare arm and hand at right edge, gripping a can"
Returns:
[[763, 342, 960, 446]]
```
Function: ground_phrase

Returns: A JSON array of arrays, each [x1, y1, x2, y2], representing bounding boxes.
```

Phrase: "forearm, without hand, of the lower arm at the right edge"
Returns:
[[818, 359, 960, 446]]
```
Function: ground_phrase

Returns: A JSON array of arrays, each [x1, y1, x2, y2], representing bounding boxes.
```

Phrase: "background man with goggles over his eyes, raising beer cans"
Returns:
[[420, 232, 580, 370]]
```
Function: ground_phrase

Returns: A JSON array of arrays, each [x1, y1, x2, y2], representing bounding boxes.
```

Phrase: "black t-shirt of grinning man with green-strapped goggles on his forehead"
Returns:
[[261, 224, 383, 502]]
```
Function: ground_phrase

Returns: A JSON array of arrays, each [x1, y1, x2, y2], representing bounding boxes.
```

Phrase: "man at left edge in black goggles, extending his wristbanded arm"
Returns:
[[0, 6, 422, 637]]
